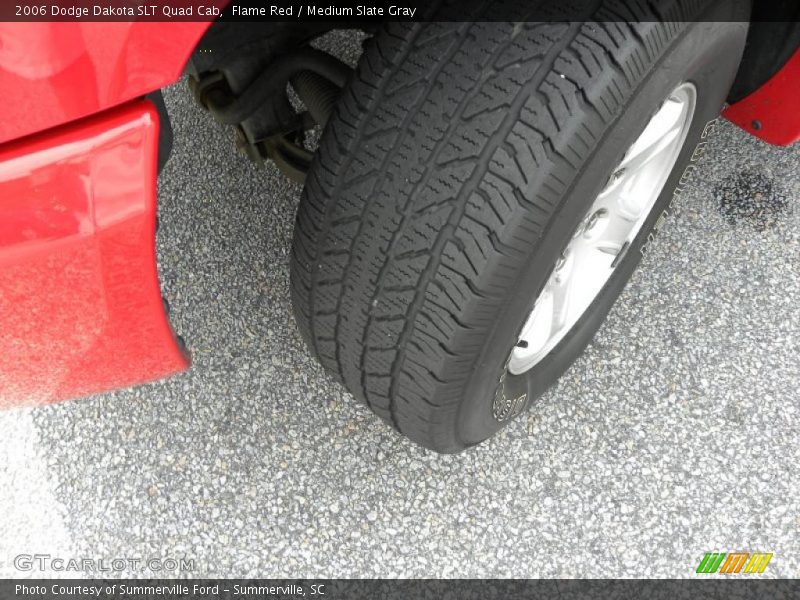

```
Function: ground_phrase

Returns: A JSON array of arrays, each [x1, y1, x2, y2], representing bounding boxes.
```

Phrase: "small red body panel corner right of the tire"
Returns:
[[722, 50, 800, 146]]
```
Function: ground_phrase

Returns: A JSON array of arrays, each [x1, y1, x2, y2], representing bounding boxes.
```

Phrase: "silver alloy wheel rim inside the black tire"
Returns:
[[507, 82, 697, 375]]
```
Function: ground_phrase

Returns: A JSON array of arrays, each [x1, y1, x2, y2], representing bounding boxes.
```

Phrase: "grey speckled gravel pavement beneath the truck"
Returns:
[[0, 30, 800, 577]]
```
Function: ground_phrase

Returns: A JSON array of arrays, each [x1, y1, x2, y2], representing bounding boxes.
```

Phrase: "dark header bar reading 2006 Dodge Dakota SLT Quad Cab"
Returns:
[[0, 0, 800, 25]]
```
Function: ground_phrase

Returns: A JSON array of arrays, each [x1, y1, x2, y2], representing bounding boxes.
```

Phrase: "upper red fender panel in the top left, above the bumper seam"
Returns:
[[0, 22, 210, 143]]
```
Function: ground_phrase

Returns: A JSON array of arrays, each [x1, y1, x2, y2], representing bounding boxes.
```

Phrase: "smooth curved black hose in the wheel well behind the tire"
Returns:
[[209, 48, 351, 125]]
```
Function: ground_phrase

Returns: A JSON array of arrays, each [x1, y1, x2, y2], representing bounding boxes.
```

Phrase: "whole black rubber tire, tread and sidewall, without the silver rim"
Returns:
[[291, 1, 747, 453]]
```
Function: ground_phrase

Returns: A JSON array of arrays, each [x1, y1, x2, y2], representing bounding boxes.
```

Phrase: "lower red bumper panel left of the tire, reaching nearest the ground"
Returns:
[[0, 100, 188, 407]]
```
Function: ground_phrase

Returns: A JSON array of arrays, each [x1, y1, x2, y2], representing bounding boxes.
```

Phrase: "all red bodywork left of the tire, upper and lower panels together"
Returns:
[[0, 22, 210, 407]]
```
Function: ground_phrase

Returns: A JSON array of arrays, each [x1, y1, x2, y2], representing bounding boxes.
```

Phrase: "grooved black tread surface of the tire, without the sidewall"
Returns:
[[291, 8, 692, 452]]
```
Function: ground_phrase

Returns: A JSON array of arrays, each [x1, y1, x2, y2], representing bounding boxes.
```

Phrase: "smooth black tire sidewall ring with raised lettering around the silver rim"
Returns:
[[457, 22, 747, 446]]
